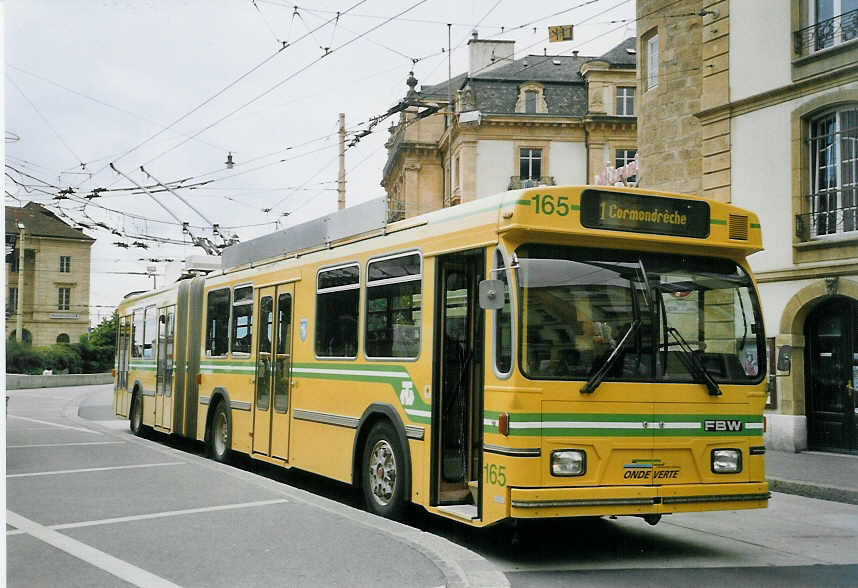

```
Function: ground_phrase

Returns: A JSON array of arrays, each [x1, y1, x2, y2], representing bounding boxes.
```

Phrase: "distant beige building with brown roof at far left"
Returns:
[[5, 202, 95, 345]]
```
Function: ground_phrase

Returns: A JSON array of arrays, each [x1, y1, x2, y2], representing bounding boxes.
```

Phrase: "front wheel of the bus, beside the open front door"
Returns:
[[361, 421, 406, 520]]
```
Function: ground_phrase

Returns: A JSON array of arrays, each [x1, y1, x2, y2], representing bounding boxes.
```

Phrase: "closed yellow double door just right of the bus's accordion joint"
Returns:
[[253, 285, 293, 460]]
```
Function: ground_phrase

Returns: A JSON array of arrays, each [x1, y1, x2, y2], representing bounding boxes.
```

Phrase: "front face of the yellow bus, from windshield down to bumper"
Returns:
[[484, 244, 768, 523]]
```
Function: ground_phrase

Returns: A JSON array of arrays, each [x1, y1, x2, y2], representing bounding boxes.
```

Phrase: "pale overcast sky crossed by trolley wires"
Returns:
[[0, 0, 635, 323]]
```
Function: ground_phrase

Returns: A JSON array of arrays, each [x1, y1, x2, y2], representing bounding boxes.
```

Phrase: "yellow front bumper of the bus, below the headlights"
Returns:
[[510, 482, 769, 519]]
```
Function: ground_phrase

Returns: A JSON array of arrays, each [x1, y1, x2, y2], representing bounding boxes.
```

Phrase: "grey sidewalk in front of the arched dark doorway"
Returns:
[[766, 450, 858, 504]]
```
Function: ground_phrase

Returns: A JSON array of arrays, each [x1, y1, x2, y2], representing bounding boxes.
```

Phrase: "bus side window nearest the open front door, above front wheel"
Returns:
[[364, 253, 422, 359]]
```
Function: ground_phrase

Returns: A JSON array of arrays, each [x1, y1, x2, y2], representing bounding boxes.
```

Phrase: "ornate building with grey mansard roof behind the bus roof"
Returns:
[[381, 37, 637, 219]]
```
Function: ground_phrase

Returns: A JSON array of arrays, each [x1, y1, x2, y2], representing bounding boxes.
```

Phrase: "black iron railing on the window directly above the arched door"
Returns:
[[795, 192, 858, 243]]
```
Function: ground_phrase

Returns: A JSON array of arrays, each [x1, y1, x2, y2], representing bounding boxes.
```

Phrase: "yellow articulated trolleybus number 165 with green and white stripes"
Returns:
[[115, 186, 769, 526]]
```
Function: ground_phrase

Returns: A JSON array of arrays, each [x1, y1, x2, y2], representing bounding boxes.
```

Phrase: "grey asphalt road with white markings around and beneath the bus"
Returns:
[[6, 386, 858, 588]]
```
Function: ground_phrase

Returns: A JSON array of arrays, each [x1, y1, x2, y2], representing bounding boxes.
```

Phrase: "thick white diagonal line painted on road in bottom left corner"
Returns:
[[6, 510, 178, 587]]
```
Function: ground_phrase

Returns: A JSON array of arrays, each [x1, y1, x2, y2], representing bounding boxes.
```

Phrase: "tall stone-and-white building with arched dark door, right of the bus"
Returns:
[[637, 0, 858, 452]]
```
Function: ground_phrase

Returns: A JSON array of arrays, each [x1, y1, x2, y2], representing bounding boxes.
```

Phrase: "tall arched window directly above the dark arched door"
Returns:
[[808, 105, 858, 238]]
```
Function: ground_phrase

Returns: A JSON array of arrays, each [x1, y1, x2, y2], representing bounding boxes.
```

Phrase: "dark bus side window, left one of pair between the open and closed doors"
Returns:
[[316, 263, 360, 359]]
